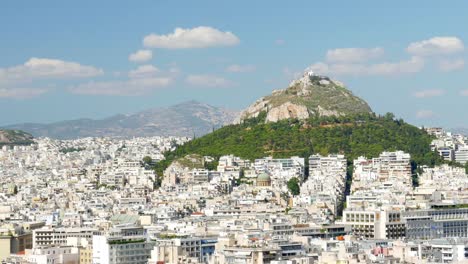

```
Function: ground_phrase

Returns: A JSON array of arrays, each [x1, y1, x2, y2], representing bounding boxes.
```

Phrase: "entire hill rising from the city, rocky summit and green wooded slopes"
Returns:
[[156, 70, 442, 175]]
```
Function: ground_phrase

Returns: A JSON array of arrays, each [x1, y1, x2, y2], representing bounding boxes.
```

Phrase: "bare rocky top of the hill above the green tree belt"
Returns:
[[236, 70, 372, 122]]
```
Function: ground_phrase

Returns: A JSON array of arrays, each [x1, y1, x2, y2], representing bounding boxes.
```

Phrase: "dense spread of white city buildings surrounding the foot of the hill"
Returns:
[[0, 128, 468, 264]]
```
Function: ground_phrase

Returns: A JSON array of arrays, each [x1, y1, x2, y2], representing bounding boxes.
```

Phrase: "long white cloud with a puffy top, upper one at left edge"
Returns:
[[0, 58, 104, 81]]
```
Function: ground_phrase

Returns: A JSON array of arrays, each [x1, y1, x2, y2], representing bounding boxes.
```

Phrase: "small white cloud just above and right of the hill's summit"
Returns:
[[326, 47, 384, 63]]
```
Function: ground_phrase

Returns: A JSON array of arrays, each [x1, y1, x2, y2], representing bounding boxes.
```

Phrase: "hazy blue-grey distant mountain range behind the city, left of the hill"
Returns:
[[4, 101, 238, 139]]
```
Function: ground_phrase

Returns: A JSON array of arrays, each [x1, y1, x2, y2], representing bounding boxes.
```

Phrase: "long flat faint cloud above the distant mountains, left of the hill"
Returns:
[[69, 77, 171, 96]]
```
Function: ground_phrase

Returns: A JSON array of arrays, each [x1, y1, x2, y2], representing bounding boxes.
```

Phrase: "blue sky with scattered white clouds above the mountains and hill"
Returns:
[[0, 0, 468, 127]]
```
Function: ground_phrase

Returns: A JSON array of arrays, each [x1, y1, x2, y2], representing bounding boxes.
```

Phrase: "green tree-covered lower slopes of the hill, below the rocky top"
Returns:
[[156, 112, 442, 179]]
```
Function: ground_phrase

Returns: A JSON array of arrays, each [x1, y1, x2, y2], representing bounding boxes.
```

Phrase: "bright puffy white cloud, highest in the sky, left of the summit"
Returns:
[[143, 27, 240, 49]]
